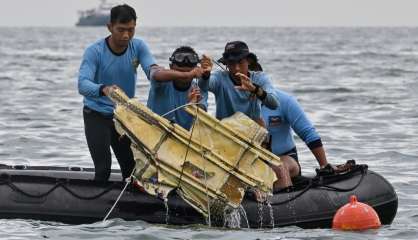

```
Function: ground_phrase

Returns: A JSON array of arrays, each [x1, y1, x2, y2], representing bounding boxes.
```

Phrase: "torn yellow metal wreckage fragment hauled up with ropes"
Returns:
[[109, 89, 281, 216]]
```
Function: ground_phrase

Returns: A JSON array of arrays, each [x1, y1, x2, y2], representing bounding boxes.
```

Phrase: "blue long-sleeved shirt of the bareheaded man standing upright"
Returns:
[[78, 38, 155, 115]]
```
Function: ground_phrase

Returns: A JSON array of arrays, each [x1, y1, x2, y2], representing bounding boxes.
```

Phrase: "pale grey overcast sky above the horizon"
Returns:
[[0, 0, 418, 26]]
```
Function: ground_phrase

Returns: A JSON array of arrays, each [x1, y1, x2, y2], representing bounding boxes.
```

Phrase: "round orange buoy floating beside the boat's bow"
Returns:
[[332, 195, 382, 230]]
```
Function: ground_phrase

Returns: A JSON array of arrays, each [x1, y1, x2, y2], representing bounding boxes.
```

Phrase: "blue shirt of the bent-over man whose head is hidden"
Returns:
[[262, 89, 320, 155]]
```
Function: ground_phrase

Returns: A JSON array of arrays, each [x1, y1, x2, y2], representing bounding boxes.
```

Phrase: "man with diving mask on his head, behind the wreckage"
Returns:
[[147, 46, 207, 129]]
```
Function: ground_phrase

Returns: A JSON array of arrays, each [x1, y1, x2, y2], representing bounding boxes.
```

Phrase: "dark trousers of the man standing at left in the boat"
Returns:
[[83, 107, 135, 181]]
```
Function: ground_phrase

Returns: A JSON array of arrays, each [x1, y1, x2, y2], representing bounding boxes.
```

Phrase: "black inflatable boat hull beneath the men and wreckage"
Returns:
[[0, 165, 398, 228]]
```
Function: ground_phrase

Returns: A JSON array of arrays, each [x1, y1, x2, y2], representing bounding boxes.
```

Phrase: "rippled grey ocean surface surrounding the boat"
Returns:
[[0, 27, 418, 240]]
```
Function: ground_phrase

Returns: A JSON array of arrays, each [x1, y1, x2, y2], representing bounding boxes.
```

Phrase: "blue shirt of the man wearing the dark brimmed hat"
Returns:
[[199, 71, 278, 120]]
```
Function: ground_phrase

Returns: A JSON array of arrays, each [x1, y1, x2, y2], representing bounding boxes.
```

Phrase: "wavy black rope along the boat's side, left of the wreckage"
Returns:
[[0, 179, 115, 200]]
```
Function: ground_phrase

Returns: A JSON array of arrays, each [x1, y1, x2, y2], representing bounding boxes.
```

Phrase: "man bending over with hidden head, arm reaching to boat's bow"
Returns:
[[262, 89, 328, 190]]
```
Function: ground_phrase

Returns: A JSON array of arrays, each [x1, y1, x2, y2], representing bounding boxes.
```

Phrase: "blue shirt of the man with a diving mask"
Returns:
[[147, 67, 208, 129]]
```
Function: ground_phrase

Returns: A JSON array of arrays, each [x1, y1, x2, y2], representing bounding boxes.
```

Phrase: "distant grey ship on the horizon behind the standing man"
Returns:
[[76, 0, 112, 26]]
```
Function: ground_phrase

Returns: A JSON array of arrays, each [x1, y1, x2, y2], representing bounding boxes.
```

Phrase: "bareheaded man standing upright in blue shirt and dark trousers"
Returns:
[[78, 4, 155, 181]]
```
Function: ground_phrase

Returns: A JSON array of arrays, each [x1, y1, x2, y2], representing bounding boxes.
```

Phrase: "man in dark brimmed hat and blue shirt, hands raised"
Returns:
[[199, 41, 278, 126]]
